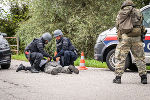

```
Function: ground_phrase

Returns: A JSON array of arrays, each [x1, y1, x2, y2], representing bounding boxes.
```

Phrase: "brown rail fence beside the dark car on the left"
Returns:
[[5, 37, 19, 55]]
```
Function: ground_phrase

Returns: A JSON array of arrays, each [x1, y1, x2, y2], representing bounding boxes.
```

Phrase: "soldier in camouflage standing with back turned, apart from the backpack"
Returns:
[[113, 0, 147, 84]]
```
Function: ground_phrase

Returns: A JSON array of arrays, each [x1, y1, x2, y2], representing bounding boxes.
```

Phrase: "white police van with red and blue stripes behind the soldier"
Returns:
[[94, 5, 150, 71]]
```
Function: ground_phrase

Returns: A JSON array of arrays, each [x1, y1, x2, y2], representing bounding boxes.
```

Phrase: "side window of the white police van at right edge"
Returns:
[[142, 8, 150, 28]]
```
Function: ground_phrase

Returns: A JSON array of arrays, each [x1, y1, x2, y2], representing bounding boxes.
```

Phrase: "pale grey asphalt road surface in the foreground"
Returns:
[[0, 60, 150, 100]]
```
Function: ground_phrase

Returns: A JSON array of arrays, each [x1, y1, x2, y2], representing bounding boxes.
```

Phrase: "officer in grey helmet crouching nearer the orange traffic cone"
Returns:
[[53, 29, 79, 74]]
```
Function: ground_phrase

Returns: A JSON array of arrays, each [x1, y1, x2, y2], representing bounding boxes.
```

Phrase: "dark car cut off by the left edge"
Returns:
[[0, 32, 11, 69]]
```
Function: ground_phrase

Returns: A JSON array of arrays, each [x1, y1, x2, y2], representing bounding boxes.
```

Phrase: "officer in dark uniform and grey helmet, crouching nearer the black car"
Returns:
[[16, 32, 52, 73]]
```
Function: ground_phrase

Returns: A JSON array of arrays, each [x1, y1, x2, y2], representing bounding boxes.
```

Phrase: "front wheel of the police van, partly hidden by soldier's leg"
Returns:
[[106, 49, 131, 71]]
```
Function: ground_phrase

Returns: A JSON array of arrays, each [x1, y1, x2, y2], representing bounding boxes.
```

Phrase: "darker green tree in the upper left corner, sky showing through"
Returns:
[[0, 2, 29, 36]]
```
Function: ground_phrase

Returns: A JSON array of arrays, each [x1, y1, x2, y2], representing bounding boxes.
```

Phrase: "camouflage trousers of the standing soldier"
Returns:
[[115, 34, 147, 76]]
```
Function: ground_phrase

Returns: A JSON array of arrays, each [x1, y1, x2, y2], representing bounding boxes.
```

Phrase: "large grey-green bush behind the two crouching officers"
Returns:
[[1, 0, 149, 57]]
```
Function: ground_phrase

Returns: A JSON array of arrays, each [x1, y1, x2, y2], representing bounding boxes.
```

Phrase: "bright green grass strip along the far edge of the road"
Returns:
[[12, 54, 150, 70]]
